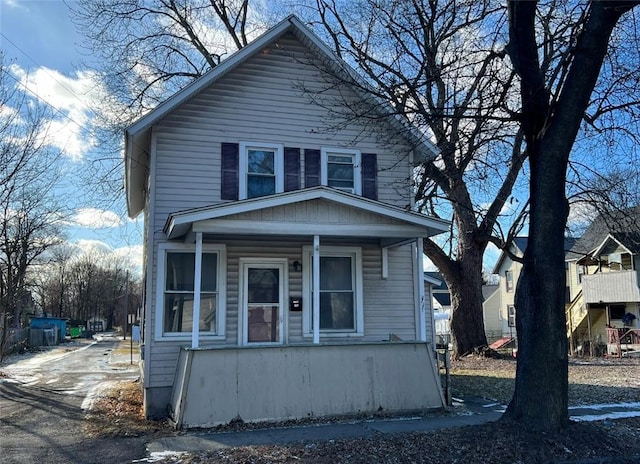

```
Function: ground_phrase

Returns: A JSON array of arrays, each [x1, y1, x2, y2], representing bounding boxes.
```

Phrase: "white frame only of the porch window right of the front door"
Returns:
[[302, 245, 364, 337]]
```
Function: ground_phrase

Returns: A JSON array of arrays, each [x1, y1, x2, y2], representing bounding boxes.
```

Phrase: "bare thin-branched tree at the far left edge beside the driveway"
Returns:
[[0, 57, 63, 334]]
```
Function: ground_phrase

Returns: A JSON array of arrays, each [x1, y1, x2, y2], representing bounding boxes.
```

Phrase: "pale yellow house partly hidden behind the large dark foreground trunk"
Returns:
[[483, 237, 575, 339]]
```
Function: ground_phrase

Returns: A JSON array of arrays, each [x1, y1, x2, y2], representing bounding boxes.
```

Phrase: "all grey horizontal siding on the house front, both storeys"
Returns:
[[145, 32, 415, 387]]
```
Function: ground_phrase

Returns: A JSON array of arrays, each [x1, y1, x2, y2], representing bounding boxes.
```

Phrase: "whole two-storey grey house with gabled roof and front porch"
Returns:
[[125, 16, 448, 427]]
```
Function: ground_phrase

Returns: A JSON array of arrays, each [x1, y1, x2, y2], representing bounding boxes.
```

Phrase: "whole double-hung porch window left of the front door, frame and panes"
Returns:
[[156, 244, 225, 338]]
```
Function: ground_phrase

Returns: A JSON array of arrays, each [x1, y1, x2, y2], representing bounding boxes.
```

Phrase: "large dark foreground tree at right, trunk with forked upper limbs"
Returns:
[[504, 0, 640, 430]]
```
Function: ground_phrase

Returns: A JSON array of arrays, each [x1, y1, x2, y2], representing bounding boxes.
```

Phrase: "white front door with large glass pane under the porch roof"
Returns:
[[241, 259, 286, 345]]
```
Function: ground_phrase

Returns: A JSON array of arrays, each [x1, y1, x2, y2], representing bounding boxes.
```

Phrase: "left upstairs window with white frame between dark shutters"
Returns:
[[239, 142, 284, 200]]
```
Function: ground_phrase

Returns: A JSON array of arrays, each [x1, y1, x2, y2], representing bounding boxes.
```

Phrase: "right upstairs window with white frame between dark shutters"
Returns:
[[320, 148, 362, 195]]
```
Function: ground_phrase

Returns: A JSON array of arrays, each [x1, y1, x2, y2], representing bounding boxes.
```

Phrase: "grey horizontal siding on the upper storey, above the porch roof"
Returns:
[[153, 34, 411, 234]]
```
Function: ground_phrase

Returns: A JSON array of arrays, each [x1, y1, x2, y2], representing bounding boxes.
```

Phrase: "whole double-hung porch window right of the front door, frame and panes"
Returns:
[[303, 247, 363, 336]]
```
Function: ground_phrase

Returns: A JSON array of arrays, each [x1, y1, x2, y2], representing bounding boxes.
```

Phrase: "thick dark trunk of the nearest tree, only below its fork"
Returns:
[[507, 140, 569, 430]]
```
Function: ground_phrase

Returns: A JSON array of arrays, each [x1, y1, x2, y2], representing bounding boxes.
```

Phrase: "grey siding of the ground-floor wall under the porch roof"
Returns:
[[147, 240, 420, 387]]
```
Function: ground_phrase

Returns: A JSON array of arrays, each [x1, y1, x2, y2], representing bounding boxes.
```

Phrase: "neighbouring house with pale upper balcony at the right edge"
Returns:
[[567, 208, 640, 355]]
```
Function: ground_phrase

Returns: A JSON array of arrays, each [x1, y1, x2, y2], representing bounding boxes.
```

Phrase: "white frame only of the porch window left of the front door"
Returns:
[[155, 242, 227, 341]]
